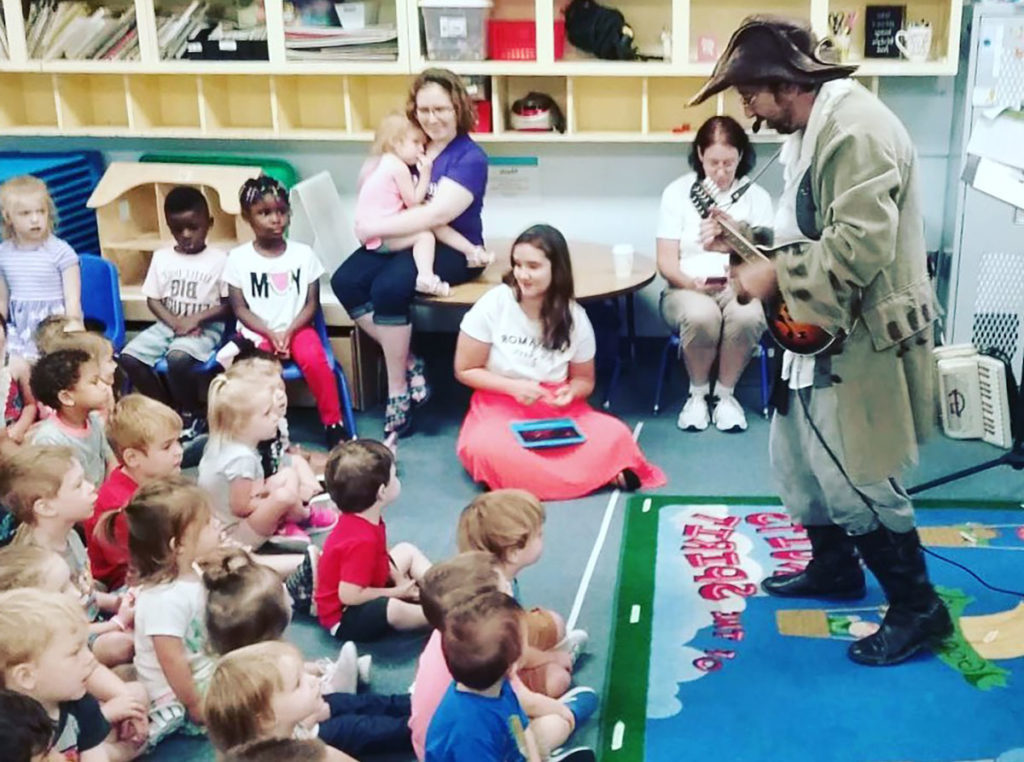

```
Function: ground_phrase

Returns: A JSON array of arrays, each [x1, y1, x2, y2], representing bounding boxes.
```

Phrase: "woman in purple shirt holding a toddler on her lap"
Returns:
[[331, 69, 487, 434]]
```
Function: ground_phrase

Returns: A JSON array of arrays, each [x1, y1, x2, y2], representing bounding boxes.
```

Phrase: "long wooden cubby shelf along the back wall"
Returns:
[[0, 0, 961, 142]]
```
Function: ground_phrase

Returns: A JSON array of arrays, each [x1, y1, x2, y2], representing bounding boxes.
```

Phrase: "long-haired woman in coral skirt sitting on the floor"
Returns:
[[455, 225, 665, 500]]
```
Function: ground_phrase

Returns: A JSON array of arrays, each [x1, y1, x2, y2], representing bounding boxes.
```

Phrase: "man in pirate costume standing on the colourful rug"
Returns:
[[690, 15, 952, 666]]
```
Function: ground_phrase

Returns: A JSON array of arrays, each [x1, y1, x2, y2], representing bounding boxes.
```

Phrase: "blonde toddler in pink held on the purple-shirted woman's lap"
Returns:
[[355, 113, 495, 296]]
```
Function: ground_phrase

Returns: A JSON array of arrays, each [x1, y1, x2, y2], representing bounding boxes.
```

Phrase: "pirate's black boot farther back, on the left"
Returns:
[[761, 524, 865, 600]]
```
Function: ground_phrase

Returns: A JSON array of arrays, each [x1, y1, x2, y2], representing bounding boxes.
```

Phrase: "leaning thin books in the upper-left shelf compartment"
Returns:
[[26, 0, 138, 60]]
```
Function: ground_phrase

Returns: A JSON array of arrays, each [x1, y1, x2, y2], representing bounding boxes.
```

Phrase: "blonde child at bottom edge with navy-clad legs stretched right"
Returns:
[[203, 640, 409, 757]]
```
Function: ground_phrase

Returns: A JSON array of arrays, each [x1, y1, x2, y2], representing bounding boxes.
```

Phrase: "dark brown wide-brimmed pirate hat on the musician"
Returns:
[[687, 15, 857, 105]]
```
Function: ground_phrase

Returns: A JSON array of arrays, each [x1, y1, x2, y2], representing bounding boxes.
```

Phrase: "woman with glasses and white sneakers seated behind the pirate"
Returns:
[[657, 117, 774, 431]]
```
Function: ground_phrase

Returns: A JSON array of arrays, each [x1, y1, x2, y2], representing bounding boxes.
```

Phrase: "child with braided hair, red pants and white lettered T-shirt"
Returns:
[[217, 175, 347, 448]]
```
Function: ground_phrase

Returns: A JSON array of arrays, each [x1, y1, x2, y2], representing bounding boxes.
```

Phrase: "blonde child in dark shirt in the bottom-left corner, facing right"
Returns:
[[0, 588, 144, 762]]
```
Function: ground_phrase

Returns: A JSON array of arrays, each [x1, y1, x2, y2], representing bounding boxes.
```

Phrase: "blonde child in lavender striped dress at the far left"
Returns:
[[0, 175, 82, 362]]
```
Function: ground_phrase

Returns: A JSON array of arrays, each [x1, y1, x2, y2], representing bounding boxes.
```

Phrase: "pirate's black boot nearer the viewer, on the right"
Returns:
[[849, 526, 953, 667]]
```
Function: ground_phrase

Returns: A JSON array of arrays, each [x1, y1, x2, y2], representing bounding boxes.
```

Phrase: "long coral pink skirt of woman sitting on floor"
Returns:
[[456, 391, 666, 500]]
